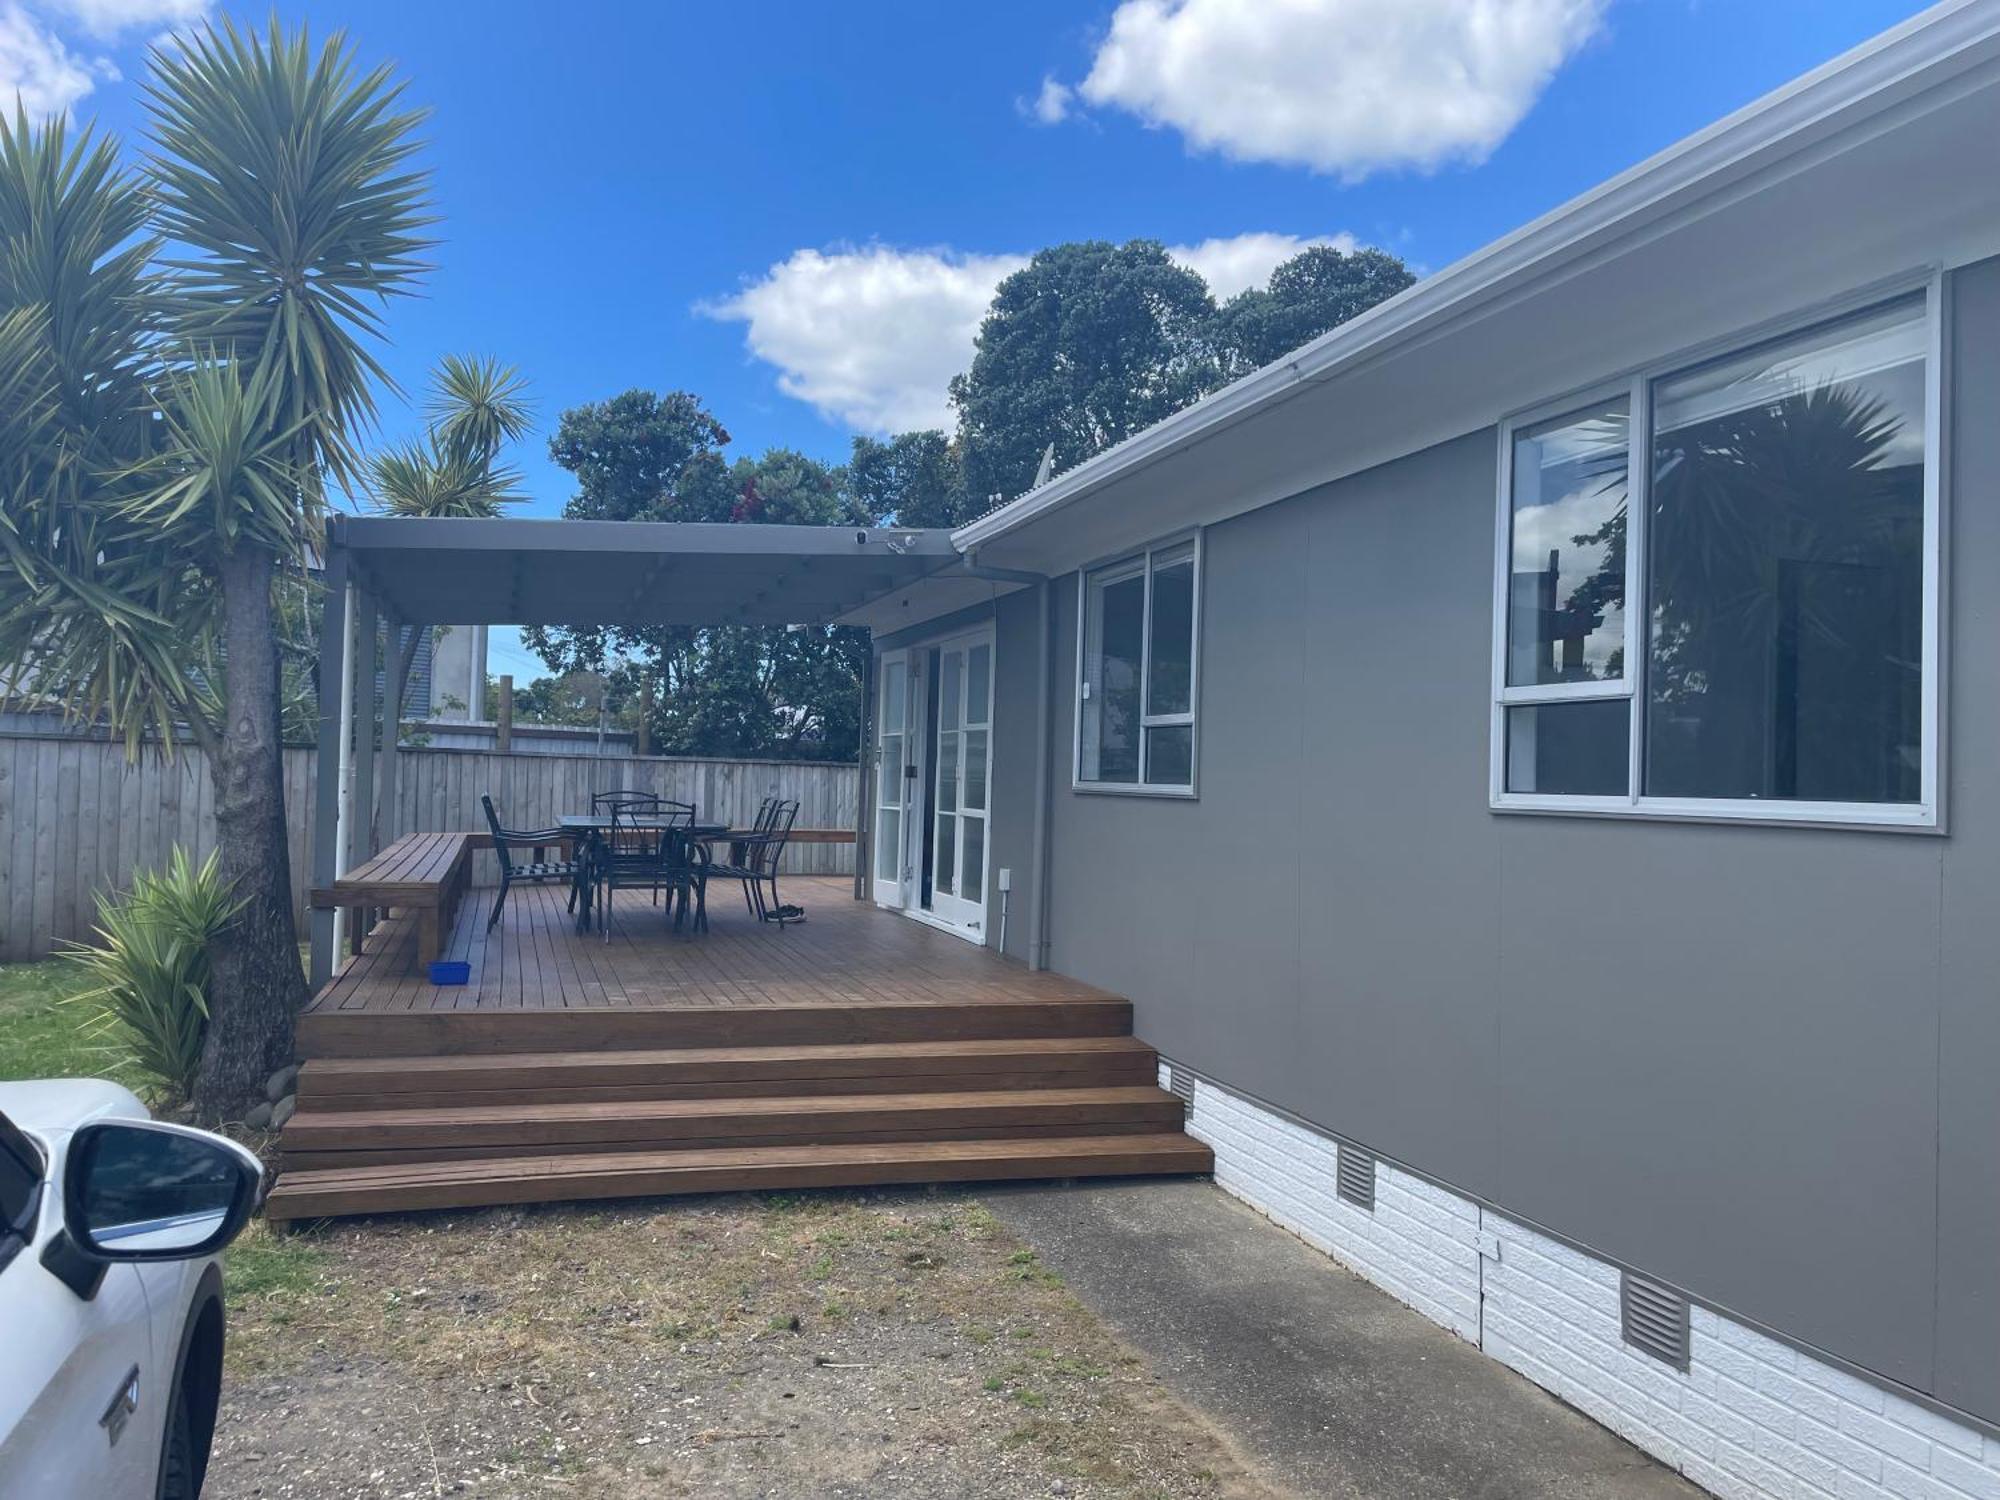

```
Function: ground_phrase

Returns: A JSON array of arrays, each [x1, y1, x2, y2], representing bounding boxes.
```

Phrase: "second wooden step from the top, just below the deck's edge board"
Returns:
[[298, 1036, 1158, 1112]]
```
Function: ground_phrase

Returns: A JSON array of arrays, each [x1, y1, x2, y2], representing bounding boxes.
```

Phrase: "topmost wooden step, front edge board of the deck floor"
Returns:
[[298, 1000, 1132, 1058]]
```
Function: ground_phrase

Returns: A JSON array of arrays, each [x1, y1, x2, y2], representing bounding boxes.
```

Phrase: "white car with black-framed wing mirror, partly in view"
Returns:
[[0, 1080, 264, 1500]]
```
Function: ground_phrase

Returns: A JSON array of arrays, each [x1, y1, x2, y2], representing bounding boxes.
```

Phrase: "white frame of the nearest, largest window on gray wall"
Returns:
[[1488, 268, 1948, 832]]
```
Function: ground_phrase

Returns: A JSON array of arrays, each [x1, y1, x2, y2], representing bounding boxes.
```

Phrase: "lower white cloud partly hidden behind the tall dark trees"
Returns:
[[696, 232, 1354, 432]]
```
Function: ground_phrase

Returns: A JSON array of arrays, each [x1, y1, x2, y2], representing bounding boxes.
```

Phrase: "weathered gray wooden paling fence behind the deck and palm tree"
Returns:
[[0, 732, 860, 962]]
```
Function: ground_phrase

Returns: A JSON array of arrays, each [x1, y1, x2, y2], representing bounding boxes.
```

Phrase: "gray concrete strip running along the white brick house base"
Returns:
[[980, 1182, 1702, 1500]]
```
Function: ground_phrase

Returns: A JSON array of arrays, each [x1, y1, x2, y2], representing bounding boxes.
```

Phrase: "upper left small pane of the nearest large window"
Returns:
[[1506, 400, 1628, 686]]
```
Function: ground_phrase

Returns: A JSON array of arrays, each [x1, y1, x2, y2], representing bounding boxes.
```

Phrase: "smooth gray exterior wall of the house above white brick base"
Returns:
[[996, 262, 2000, 1420]]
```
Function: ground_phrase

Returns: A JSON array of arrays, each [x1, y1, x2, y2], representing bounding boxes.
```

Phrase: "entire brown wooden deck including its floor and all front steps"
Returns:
[[266, 878, 1212, 1222]]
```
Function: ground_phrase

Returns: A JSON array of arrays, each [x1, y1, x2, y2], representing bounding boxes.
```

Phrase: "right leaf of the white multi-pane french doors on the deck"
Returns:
[[926, 634, 994, 940]]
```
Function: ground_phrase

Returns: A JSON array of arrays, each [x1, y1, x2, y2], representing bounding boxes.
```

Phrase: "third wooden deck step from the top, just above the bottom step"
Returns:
[[282, 1084, 1182, 1172]]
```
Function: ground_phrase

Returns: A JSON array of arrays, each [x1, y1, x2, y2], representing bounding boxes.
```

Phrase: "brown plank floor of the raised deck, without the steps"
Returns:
[[308, 876, 1114, 1016]]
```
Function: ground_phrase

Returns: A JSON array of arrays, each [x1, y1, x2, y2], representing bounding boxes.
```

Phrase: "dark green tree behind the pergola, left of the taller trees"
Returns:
[[522, 390, 874, 760]]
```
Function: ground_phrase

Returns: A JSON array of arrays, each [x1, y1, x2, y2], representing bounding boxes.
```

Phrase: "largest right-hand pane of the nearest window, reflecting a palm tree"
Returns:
[[1646, 300, 1926, 802]]
